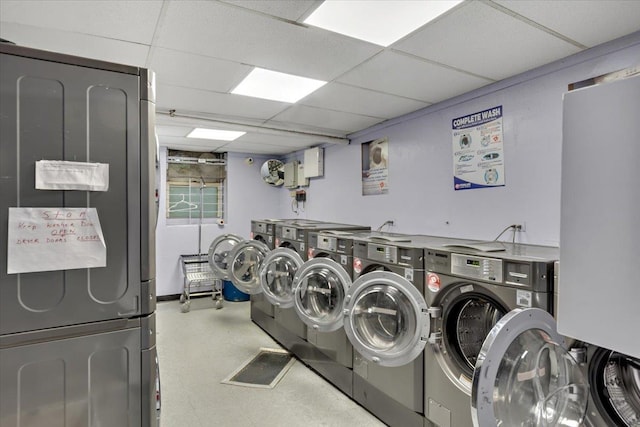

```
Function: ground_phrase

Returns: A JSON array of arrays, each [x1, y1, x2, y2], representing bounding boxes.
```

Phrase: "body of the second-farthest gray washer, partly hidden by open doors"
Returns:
[[266, 219, 370, 352]]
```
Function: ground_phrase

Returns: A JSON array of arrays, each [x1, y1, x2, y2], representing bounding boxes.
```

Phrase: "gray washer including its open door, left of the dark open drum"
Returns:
[[344, 233, 460, 427]]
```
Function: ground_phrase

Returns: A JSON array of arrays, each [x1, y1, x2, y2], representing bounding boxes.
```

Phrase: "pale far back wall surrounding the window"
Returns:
[[156, 147, 280, 295]]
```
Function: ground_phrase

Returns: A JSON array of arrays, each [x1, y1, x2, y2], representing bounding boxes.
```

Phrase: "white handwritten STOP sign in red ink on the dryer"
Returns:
[[7, 208, 107, 274]]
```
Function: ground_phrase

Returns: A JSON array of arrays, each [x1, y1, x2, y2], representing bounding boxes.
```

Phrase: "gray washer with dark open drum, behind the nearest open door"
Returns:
[[424, 242, 559, 427]]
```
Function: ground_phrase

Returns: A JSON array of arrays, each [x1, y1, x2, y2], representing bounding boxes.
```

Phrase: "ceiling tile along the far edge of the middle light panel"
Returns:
[[156, 85, 289, 120]]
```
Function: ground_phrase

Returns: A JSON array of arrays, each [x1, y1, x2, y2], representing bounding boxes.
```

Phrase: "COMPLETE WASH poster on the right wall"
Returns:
[[451, 105, 504, 190]]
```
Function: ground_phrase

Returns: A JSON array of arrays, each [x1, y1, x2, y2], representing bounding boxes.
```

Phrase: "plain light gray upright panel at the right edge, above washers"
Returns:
[[557, 74, 640, 358]]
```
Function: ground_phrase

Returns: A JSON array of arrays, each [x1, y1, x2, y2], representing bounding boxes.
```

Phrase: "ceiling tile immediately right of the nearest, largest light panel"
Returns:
[[394, 2, 580, 80]]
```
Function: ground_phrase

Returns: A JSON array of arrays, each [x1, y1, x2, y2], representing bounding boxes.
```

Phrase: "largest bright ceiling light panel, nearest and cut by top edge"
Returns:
[[304, 0, 462, 47]]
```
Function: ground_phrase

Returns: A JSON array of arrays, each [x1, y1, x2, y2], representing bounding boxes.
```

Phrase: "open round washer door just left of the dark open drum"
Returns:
[[344, 271, 430, 366]]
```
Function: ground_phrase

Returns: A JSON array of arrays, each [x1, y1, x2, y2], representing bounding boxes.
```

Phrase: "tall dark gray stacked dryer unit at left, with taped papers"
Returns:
[[0, 44, 158, 427]]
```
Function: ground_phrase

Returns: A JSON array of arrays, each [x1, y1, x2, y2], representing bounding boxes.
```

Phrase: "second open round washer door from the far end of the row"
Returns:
[[228, 240, 269, 295]]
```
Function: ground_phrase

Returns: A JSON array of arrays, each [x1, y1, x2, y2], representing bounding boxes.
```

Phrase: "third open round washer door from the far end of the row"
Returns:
[[260, 248, 303, 308]]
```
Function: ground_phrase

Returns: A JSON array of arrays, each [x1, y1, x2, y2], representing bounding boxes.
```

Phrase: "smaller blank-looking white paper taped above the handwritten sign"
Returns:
[[36, 160, 109, 191]]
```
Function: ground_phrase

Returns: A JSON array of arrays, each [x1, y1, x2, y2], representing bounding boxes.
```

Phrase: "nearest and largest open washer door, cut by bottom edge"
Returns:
[[471, 308, 589, 427]]
